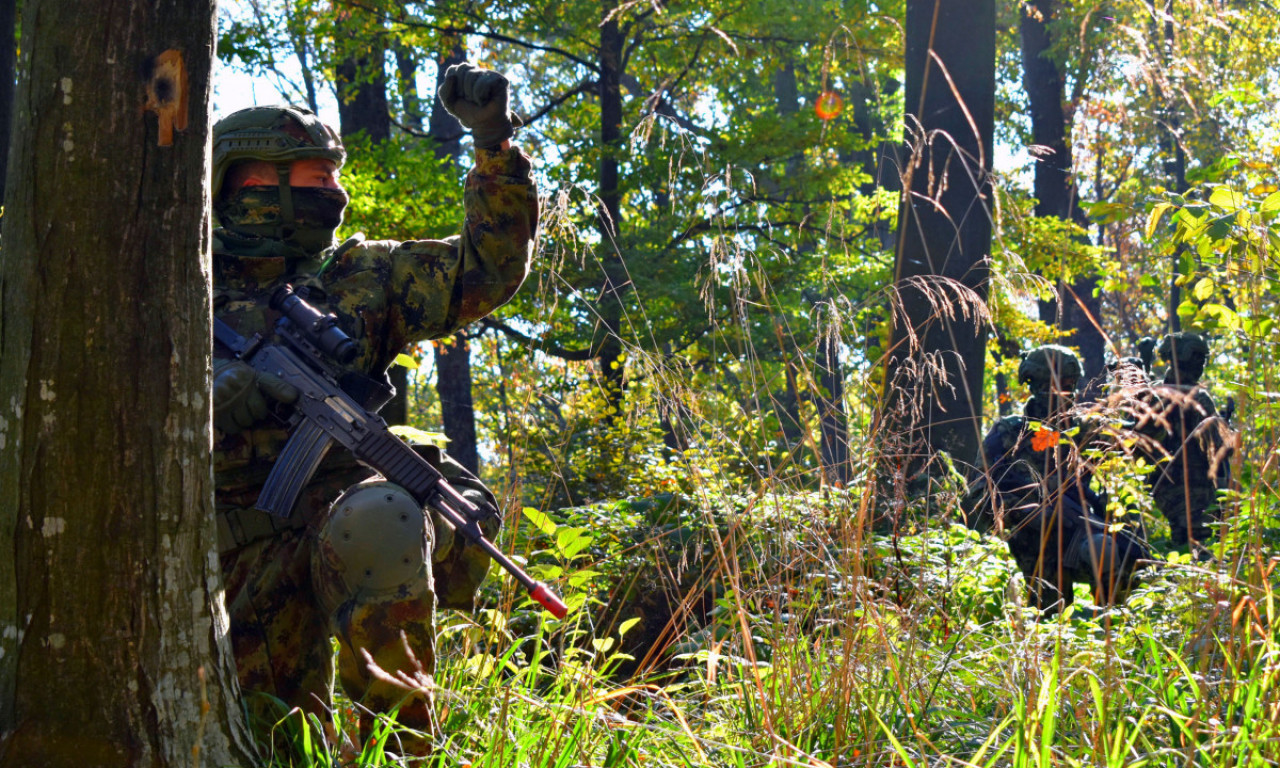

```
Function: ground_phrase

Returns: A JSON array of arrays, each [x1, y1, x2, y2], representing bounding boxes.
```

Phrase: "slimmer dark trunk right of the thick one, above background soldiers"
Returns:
[[1020, 0, 1106, 394]]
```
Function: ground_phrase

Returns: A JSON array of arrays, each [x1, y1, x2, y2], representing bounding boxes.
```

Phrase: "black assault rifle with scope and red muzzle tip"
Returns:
[[214, 285, 568, 618]]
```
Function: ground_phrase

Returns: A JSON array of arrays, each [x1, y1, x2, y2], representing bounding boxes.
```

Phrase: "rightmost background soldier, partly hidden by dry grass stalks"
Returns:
[[1139, 332, 1231, 549]]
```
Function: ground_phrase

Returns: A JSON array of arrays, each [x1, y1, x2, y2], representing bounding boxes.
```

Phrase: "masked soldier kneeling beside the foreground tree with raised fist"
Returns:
[[212, 64, 538, 755]]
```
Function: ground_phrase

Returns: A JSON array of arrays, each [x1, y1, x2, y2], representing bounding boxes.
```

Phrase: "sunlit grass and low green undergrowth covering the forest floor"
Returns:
[[257, 483, 1280, 768]]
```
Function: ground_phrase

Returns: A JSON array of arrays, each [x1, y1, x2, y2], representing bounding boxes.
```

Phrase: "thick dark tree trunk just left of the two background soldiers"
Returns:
[[883, 0, 996, 474]]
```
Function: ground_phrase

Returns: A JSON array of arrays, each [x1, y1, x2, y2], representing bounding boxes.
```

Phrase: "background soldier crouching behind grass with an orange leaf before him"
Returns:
[[970, 344, 1147, 613]]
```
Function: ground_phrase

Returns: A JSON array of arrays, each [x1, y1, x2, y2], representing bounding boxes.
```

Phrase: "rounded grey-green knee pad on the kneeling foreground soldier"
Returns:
[[319, 479, 431, 596]]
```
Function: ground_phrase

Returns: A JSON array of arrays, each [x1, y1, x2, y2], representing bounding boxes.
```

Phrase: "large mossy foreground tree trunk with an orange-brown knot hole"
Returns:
[[0, 0, 253, 768]]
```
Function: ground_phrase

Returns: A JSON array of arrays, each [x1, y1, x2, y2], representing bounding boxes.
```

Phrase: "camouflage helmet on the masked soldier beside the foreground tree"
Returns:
[[212, 105, 347, 200]]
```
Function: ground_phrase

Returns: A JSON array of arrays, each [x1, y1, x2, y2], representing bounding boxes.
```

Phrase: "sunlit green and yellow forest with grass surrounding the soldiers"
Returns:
[[0, 0, 1280, 767]]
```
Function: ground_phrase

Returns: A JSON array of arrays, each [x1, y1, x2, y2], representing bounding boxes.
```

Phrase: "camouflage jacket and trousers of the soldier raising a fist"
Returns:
[[214, 104, 538, 754]]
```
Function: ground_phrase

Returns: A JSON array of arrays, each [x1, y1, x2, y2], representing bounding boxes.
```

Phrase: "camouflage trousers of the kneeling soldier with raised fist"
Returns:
[[218, 452, 497, 755]]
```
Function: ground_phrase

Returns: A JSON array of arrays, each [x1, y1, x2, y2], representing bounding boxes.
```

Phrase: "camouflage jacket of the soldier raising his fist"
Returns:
[[214, 148, 538, 498]]
